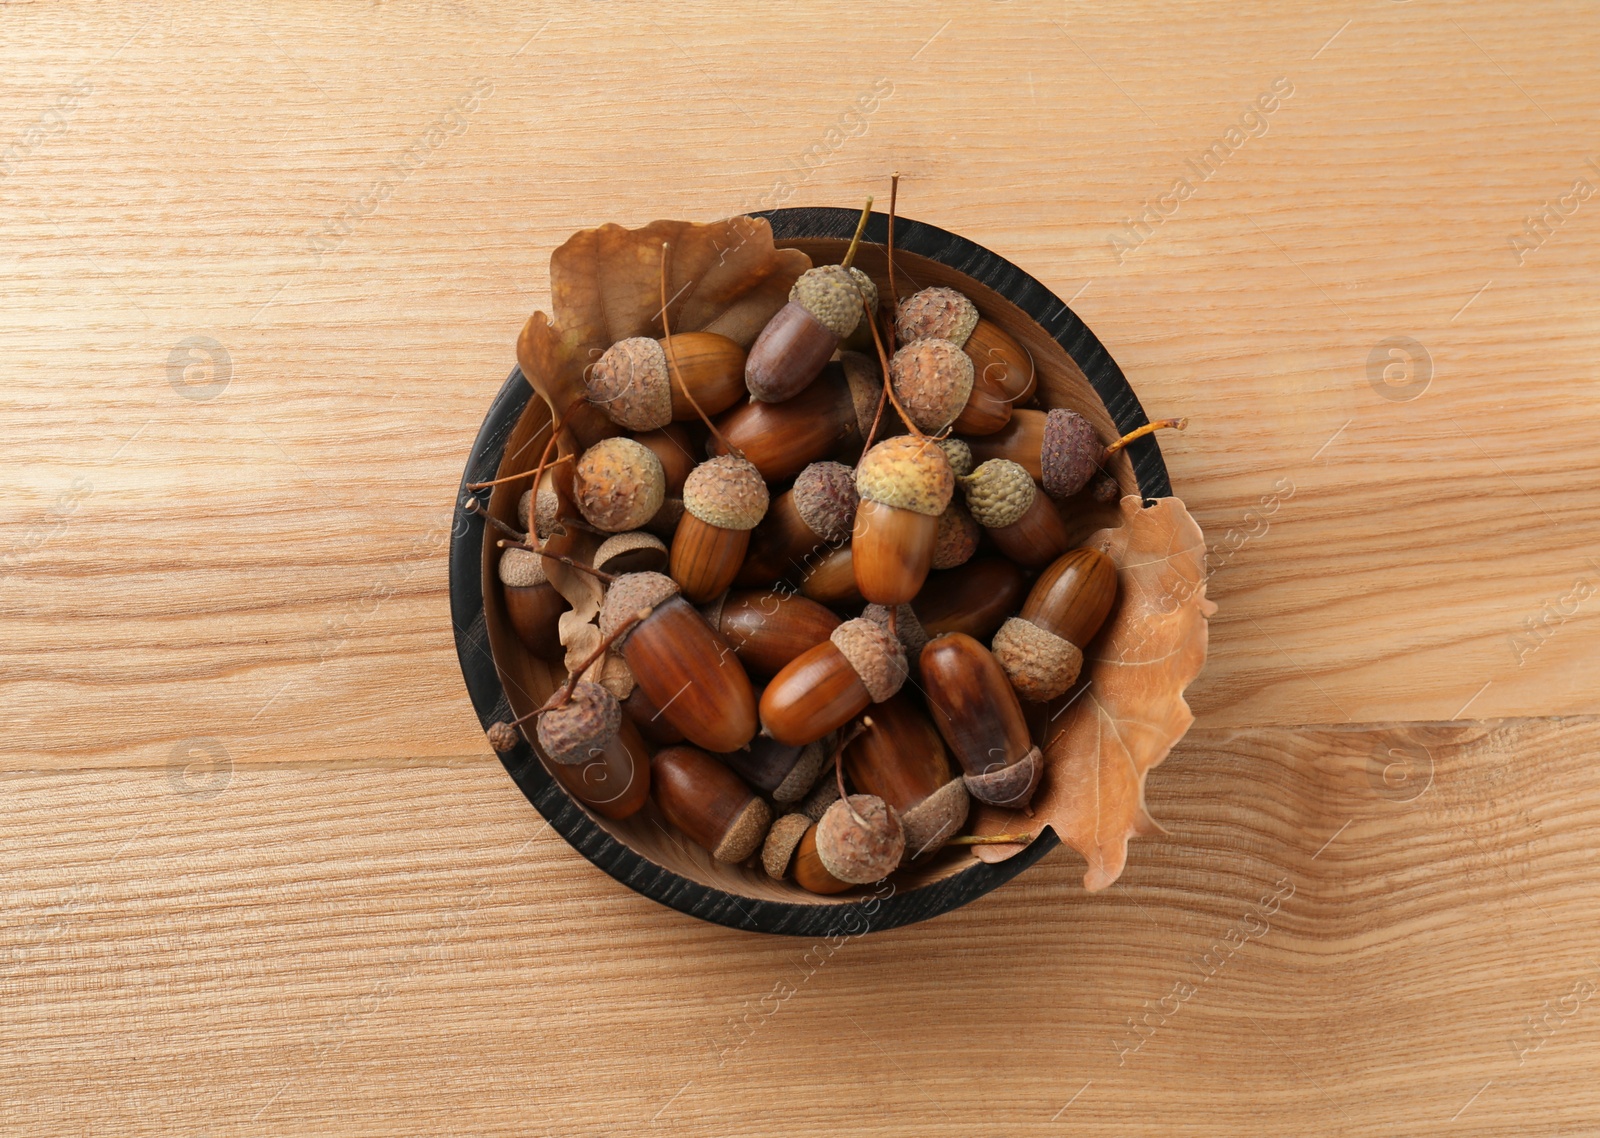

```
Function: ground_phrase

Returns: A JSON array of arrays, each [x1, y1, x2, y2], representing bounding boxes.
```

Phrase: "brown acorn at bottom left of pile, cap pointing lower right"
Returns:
[[650, 746, 773, 863]]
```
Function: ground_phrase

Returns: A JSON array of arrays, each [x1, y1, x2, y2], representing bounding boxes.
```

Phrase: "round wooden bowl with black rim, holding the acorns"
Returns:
[[450, 208, 1171, 936]]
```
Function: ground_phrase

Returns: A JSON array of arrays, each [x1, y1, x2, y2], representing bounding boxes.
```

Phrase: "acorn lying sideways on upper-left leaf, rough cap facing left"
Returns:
[[584, 331, 744, 431]]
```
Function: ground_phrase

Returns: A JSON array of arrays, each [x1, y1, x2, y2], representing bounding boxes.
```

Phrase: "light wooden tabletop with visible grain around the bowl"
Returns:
[[0, 0, 1600, 1136]]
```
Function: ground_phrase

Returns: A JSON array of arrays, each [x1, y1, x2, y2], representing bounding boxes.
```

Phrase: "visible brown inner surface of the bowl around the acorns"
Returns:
[[482, 238, 1138, 908]]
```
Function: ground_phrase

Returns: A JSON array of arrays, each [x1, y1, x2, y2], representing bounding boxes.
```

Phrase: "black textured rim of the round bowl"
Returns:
[[450, 206, 1171, 936]]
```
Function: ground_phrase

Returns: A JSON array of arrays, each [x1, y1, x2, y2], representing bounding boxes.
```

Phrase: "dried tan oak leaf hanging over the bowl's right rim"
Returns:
[[973, 496, 1216, 892]]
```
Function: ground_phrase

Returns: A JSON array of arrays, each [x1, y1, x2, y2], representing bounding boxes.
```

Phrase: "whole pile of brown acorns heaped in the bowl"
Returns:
[[490, 214, 1181, 893]]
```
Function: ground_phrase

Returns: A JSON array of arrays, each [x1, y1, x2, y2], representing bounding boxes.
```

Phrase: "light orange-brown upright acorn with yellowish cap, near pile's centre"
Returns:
[[851, 435, 955, 605]]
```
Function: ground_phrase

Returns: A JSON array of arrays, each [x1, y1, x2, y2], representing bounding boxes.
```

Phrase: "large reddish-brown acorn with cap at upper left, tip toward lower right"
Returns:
[[600, 573, 755, 751]]
